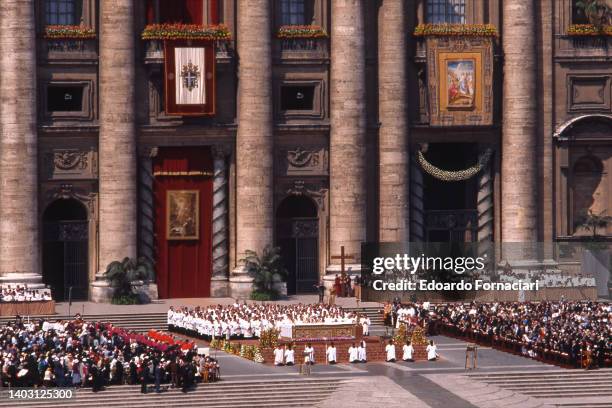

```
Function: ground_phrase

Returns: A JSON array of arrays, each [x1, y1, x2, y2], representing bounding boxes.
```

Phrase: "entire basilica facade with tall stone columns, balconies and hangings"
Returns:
[[0, 0, 612, 300]]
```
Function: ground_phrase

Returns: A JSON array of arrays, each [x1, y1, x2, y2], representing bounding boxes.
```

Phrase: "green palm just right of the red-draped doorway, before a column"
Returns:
[[241, 245, 287, 300]]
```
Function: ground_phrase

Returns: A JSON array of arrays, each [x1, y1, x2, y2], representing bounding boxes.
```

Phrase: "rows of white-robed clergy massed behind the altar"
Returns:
[[168, 302, 370, 341]]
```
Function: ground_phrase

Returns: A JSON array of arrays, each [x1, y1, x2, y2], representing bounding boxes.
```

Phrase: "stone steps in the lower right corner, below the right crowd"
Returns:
[[469, 369, 612, 408]]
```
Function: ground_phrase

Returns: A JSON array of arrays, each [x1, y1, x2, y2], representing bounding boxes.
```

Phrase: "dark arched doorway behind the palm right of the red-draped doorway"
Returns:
[[276, 196, 319, 295]]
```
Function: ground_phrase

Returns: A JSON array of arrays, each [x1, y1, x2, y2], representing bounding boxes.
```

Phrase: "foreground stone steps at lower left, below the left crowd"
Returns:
[[0, 377, 350, 408]]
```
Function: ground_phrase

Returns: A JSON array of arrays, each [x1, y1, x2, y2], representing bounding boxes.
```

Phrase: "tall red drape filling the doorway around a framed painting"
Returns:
[[153, 147, 213, 298]]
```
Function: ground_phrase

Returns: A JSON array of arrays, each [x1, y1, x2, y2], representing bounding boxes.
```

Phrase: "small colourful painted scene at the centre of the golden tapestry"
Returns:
[[446, 59, 476, 109]]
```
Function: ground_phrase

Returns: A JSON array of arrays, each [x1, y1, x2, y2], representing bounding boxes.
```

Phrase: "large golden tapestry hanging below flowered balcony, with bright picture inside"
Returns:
[[426, 37, 494, 126]]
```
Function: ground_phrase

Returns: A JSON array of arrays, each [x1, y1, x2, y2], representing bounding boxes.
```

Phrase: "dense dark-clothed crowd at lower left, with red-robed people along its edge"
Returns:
[[0, 315, 220, 392]]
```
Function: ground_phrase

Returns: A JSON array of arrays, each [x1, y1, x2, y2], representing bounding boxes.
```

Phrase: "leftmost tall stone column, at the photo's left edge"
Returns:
[[0, 0, 42, 286]]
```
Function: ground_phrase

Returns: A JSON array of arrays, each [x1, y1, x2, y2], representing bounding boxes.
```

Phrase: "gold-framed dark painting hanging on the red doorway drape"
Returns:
[[166, 190, 200, 240]]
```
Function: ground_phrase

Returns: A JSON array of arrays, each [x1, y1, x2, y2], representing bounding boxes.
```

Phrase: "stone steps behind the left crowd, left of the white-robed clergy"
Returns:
[[0, 312, 168, 332]]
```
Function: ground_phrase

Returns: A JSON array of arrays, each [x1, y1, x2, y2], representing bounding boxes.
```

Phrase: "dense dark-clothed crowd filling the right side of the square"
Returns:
[[428, 301, 612, 367]]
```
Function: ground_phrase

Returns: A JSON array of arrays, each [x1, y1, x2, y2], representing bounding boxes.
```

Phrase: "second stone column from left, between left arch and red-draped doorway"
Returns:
[[99, 0, 137, 271]]
